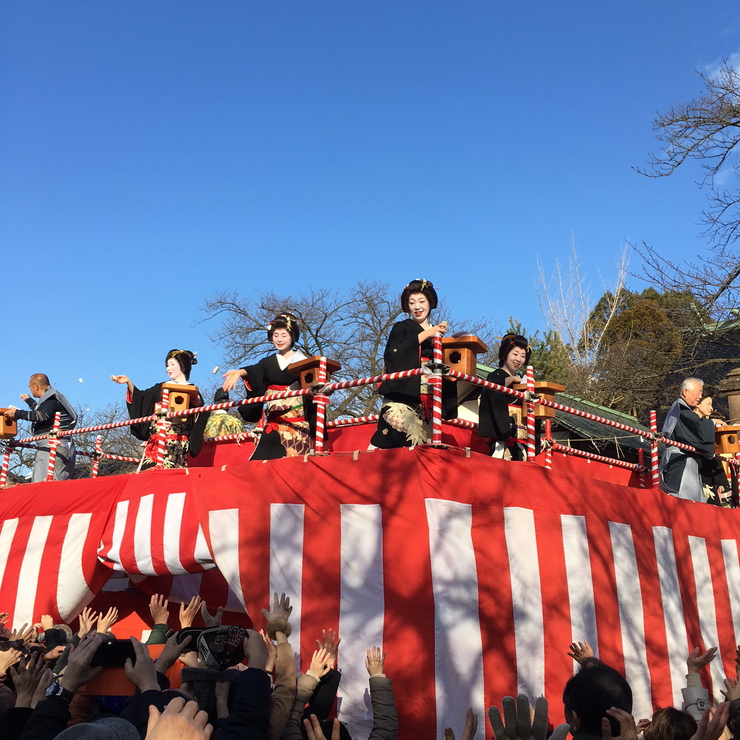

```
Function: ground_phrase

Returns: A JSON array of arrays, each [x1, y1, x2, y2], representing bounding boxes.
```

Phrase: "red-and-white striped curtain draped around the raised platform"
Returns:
[[0, 447, 740, 737]]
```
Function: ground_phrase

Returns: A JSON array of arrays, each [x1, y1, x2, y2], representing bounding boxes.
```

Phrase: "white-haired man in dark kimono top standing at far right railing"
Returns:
[[660, 378, 714, 502]]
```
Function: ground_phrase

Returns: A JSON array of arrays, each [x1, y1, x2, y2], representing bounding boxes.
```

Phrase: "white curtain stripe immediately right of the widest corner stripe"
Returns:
[[502, 507, 545, 696]]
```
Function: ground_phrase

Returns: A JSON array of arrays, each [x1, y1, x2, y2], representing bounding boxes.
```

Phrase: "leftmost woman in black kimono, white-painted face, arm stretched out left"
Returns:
[[110, 349, 208, 470]]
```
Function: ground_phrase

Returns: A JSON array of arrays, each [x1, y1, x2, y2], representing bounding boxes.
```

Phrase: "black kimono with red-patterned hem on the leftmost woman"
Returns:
[[126, 383, 209, 469]]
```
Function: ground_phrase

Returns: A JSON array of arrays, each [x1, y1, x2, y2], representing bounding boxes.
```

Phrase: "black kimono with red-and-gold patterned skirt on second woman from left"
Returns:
[[239, 354, 316, 460]]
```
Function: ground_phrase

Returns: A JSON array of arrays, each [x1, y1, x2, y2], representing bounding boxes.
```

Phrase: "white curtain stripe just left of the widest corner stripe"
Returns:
[[338, 504, 385, 737]]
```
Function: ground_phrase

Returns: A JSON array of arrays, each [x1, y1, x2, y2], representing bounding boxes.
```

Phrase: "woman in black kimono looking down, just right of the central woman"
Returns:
[[478, 334, 532, 460]]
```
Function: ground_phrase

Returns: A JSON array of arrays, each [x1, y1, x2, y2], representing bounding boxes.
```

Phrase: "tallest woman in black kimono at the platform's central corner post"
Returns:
[[370, 279, 447, 449]]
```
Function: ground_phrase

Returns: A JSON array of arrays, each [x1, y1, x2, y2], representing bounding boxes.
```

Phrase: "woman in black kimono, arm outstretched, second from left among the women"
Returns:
[[223, 312, 315, 460]]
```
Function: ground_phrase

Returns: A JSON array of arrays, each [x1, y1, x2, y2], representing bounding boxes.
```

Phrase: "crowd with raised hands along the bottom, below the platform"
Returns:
[[0, 594, 740, 740]]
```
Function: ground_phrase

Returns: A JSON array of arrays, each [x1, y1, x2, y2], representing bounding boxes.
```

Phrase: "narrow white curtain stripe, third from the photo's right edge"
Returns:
[[653, 527, 689, 707]]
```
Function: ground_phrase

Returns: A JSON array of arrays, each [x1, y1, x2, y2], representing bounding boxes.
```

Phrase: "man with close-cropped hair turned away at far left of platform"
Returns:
[[5, 373, 77, 483]]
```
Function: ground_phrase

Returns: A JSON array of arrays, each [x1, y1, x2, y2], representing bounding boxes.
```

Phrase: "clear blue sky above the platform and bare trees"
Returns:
[[0, 0, 740, 414]]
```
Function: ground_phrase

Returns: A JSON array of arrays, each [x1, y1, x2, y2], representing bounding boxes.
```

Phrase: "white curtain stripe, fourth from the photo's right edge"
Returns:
[[609, 522, 653, 717]]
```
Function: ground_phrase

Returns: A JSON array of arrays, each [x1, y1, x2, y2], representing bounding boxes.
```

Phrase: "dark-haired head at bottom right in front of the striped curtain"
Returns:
[[563, 658, 632, 737]]
